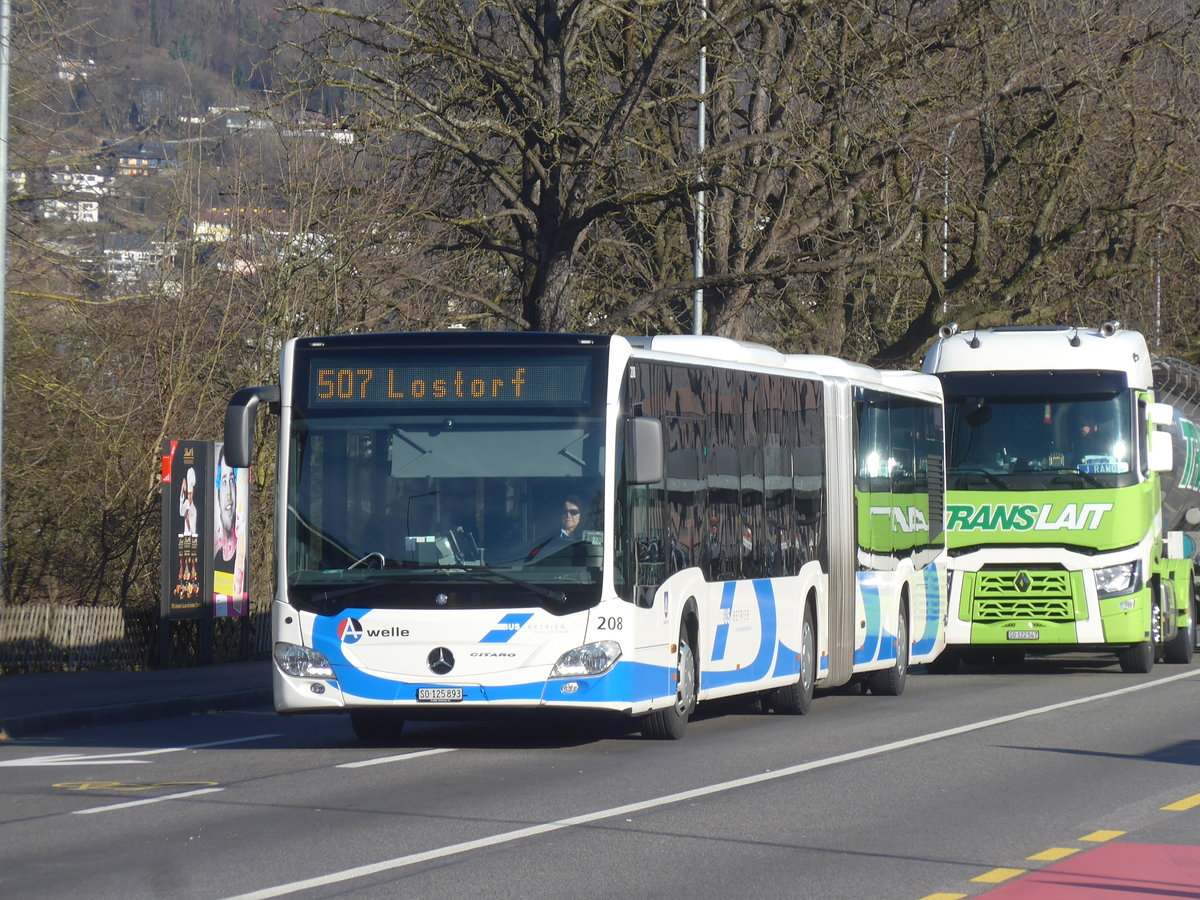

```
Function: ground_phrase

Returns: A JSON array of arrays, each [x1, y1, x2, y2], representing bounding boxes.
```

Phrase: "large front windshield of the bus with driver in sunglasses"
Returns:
[[286, 410, 604, 588]]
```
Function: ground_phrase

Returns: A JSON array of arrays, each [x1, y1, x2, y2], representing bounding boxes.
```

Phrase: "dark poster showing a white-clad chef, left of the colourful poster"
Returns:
[[160, 440, 212, 619]]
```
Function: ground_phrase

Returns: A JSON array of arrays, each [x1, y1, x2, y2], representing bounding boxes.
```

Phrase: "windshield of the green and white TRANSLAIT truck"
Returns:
[[944, 377, 1139, 491]]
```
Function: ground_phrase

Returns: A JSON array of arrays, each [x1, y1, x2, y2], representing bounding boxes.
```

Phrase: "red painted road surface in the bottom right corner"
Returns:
[[977, 844, 1200, 900]]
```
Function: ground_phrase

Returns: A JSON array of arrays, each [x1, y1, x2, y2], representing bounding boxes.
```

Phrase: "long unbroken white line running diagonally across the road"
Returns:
[[227, 670, 1200, 900]]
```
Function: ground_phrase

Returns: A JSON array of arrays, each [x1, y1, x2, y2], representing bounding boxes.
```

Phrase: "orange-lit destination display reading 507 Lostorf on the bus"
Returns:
[[305, 353, 592, 409]]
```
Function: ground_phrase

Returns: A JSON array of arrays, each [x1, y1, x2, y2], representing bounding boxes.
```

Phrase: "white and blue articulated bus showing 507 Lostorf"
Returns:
[[224, 330, 946, 739]]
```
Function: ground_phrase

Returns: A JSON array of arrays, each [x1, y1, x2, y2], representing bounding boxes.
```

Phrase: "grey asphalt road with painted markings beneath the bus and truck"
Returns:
[[0, 656, 1200, 900]]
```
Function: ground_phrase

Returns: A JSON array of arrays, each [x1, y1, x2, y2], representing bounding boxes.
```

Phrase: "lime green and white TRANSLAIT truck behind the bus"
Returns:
[[923, 323, 1200, 672]]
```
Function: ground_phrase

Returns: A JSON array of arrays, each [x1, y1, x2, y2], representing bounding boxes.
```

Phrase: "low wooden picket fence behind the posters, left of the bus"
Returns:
[[0, 606, 271, 674]]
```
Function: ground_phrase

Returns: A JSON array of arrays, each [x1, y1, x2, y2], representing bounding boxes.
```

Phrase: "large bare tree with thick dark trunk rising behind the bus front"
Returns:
[[276, 0, 689, 330]]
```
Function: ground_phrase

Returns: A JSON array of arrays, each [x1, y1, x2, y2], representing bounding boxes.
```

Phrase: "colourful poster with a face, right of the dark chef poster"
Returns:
[[211, 443, 250, 618]]
